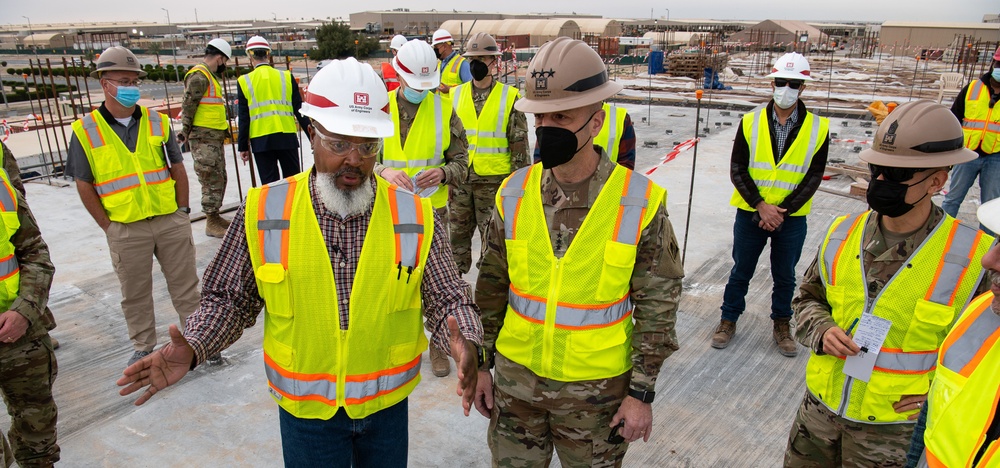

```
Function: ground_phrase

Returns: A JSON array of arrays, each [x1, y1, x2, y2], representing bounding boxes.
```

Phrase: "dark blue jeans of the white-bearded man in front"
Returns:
[[278, 399, 409, 468]]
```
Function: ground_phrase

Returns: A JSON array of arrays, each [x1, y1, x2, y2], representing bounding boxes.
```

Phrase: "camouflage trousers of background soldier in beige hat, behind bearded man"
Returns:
[[448, 182, 500, 275]]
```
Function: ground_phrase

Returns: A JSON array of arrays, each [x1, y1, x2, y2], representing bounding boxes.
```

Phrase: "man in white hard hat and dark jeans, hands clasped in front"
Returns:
[[711, 52, 830, 357]]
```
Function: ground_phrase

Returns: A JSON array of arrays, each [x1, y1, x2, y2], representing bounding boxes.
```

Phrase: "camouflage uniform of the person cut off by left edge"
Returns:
[[0, 188, 59, 467]]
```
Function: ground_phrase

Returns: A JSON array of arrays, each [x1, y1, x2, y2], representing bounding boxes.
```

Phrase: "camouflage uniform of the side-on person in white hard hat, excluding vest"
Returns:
[[181, 73, 229, 215]]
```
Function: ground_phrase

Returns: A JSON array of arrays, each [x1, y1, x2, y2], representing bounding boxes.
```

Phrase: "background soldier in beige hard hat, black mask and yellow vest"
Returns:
[[448, 33, 530, 275]]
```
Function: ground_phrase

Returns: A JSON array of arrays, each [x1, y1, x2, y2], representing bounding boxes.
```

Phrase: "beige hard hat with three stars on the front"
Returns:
[[514, 37, 623, 114]]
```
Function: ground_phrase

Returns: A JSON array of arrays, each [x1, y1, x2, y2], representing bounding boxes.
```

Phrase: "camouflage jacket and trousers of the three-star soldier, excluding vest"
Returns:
[[476, 155, 684, 466]]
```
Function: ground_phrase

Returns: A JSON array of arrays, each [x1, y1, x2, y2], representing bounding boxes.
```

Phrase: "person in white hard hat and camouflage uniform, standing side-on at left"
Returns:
[[177, 38, 233, 237]]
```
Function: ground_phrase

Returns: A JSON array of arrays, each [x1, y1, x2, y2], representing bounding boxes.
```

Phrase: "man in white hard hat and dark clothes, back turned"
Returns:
[[237, 36, 309, 184]]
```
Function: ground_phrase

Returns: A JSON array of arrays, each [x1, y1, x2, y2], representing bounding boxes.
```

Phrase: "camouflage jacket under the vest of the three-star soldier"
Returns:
[[476, 155, 684, 390]]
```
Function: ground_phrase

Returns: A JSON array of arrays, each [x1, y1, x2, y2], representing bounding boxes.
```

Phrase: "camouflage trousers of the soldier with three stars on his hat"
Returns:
[[486, 353, 630, 468]]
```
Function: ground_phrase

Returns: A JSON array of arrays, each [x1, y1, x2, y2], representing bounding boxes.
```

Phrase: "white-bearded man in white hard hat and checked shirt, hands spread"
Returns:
[[118, 58, 483, 467]]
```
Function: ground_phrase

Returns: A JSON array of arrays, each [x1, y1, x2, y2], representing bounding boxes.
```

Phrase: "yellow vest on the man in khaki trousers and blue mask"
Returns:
[[73, 107, 177, 223]]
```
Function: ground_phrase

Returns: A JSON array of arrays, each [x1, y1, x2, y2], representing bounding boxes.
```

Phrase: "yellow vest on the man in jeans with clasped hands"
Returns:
[[729, 109, 830, 216]]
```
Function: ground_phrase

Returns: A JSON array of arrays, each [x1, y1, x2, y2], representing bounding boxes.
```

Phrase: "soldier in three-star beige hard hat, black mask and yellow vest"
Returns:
[[475, 38, 684, 467]]
